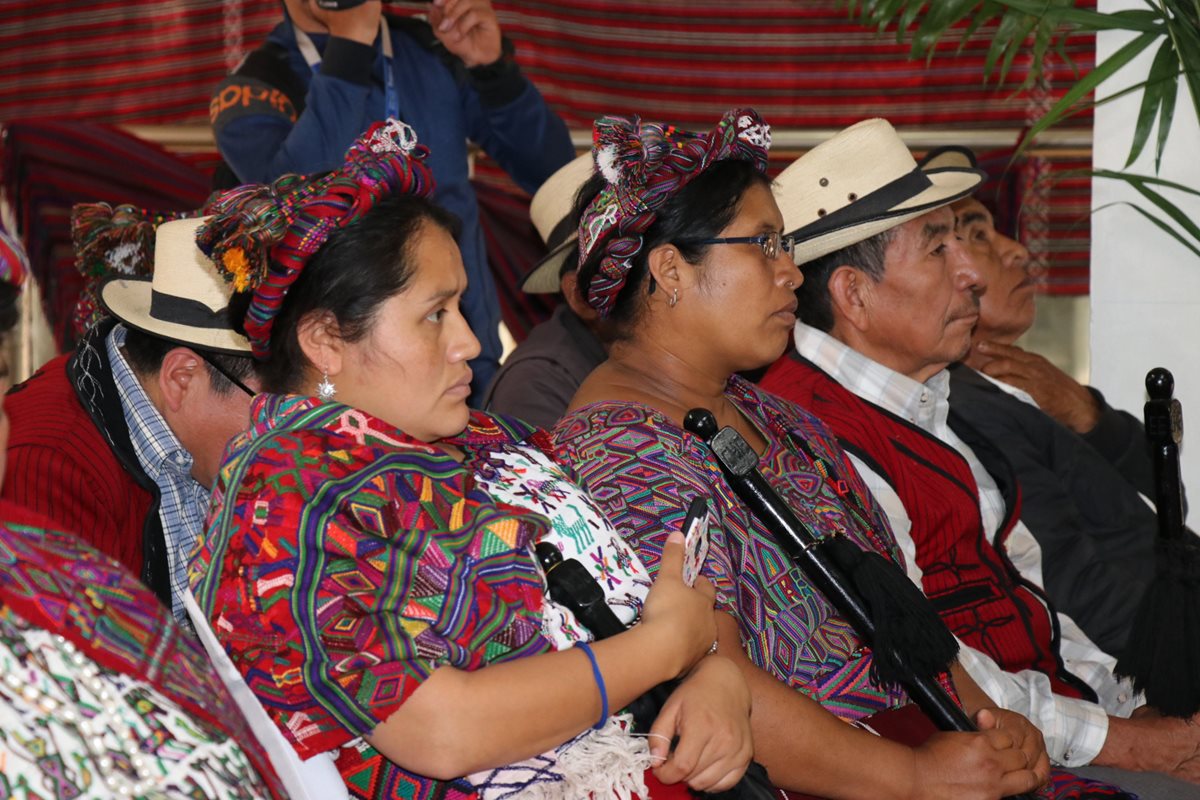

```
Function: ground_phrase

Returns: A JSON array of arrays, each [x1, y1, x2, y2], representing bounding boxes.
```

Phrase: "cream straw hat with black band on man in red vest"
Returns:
[[775, 119, 985, 264]]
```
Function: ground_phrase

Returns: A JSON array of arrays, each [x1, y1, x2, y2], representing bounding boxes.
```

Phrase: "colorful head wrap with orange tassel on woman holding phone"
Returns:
[[196, 120, 433, 359]]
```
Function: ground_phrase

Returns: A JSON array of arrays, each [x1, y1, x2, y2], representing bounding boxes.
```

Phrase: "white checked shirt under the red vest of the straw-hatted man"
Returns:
[[796, 323, 1145, 766]]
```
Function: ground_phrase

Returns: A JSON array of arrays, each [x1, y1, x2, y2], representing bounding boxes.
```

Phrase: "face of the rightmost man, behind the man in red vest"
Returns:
[[952, 198, 1042, 344]]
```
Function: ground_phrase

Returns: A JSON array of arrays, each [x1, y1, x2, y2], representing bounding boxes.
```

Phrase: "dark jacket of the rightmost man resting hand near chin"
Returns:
[[950, 365, 1158, 652]]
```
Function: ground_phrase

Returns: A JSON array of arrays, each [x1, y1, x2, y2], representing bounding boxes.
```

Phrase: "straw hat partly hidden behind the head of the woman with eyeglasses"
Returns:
[[521, 150, 595, 294]]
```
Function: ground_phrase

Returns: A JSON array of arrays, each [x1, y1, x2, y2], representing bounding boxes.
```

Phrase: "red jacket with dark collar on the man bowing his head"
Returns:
[[0, 319, 170, 608]]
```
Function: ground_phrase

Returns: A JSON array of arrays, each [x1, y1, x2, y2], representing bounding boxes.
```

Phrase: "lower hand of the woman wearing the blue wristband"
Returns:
[[650, 656, 754, 792]]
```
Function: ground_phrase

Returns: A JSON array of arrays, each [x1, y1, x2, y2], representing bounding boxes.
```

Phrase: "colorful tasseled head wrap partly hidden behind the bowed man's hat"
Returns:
[[71, 203, 193, 337]]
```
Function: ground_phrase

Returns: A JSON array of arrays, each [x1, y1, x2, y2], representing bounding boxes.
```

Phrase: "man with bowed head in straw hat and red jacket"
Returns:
[[4, 212, 257, 619]]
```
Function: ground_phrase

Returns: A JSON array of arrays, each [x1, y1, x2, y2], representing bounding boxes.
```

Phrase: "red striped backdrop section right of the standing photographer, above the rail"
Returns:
[[496, 0, 1094, 128]]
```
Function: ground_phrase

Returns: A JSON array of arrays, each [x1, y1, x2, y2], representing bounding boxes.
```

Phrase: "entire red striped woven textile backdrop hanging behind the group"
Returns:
[[0, 0, 1094, 330]]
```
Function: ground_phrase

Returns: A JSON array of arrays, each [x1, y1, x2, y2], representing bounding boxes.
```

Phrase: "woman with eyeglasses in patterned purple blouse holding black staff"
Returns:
[[554, 110, 1044, 799]]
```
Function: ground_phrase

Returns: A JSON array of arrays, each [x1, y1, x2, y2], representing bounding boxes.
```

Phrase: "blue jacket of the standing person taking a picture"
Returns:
[[211, 20, 575, 396]]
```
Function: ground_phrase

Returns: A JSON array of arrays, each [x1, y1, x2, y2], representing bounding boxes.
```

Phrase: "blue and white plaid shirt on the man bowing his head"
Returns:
[[107, 325, 209, 621]]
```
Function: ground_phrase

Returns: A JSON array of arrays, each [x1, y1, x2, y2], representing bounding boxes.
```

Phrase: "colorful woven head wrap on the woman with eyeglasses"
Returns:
[[580, 108, 770, 317]]
